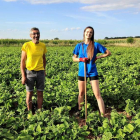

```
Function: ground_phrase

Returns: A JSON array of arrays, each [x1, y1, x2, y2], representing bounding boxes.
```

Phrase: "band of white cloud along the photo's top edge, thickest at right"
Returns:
[[4, 0, 140, 12]]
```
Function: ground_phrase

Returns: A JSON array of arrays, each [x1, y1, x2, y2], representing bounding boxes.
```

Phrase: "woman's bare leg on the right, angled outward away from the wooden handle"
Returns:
[[90, 80, 105, 115]]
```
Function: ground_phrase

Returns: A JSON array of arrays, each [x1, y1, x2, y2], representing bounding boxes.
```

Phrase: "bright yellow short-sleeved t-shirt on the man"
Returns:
[[21, 41, 47, 71]]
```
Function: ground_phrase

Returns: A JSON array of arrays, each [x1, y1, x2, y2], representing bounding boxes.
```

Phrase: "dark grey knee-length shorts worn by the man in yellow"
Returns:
[[25, 70, 45, 91]]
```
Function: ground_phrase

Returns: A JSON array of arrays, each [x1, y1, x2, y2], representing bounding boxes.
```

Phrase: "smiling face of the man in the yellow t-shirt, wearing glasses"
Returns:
[[30, 30, 40, 44]]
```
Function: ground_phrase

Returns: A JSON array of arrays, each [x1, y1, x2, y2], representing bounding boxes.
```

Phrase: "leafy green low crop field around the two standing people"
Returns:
[[0, 46, 140, 140]]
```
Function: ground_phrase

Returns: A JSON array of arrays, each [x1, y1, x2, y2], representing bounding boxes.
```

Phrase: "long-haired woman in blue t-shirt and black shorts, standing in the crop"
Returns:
[[73, 26, 111, 115]]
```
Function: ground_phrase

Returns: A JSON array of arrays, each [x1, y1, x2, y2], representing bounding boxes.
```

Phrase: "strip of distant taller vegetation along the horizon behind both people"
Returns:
[[0, 36, 140, 47]]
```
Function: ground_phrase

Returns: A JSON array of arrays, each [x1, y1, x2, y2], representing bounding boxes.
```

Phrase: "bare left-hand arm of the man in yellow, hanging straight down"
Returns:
[[20, 51, 27, 85]]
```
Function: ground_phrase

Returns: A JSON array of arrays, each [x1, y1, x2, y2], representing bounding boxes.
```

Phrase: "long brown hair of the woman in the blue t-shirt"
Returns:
[[83, 26, 94, 60]]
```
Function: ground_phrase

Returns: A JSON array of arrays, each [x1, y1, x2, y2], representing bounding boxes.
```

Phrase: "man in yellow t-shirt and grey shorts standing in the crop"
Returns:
[[21, 27, 47, 110]]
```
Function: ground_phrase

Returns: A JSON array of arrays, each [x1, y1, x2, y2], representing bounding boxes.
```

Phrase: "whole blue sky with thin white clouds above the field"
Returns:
[[0, 0, 140, 40]]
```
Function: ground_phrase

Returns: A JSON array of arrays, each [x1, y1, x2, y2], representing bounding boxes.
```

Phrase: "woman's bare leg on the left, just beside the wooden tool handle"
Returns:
[[78, 80, 85, 110]]
